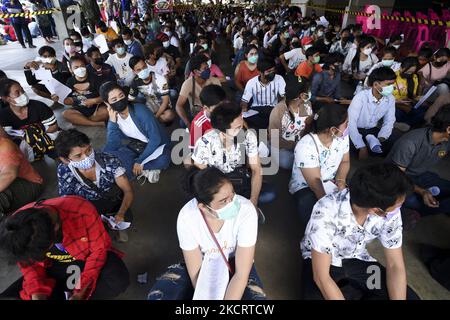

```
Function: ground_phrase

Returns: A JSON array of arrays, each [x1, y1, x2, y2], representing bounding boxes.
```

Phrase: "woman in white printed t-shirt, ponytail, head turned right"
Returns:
[[289, 104, 350, 225]]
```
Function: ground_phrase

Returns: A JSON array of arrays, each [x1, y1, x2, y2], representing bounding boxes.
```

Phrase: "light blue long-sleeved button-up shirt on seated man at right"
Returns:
[[348, 88, 395, 149]]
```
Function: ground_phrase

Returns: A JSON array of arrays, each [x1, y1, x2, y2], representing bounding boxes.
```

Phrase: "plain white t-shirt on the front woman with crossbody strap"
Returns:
[[177, 195, 258, 258]]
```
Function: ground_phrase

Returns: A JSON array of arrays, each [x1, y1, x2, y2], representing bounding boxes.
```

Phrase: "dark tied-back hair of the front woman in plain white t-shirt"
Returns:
[[183, 167, 230, 205]]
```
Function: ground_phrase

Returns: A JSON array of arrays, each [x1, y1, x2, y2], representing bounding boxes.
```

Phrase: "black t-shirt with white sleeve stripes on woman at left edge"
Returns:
[[0, 100, 56, 130]]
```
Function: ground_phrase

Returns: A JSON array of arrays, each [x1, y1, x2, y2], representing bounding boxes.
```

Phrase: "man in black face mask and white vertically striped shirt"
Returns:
[[241, 59, 286, 129]]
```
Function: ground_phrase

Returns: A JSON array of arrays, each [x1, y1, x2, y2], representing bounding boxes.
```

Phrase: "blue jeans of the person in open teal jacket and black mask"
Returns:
[[108, 145, 171, 180]]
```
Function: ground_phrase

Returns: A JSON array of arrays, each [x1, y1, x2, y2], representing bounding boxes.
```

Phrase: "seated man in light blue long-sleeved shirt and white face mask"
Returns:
[[348, 67, 398, 160]]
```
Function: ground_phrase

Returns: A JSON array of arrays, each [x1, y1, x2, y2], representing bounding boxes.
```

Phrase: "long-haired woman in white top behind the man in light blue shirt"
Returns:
[[343, 37, 378, 88]]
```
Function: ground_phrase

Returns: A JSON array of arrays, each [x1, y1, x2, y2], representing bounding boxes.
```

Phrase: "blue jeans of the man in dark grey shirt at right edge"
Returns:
[[403, 172, 450, 215]]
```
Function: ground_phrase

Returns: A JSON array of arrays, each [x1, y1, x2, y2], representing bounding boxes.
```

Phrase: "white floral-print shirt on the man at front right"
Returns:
[[301, 189, 403, 267]]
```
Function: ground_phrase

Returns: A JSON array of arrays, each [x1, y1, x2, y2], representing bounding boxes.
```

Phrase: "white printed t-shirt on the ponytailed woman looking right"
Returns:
[[289, 133, 350, 194]]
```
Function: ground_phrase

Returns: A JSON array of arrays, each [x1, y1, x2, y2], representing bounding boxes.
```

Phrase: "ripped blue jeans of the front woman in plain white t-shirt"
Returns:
[[147, 263, 266, 300]]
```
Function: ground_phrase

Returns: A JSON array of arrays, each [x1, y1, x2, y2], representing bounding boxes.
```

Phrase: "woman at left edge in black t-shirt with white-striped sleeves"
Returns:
[[0, 79, 59, 160]]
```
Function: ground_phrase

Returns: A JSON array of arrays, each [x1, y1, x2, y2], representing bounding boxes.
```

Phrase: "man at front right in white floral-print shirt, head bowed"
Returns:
[[301, 164, 419, 300]]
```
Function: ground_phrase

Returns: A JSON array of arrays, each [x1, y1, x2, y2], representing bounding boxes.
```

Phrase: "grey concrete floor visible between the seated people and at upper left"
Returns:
[[0, 39, 450, 300]]
